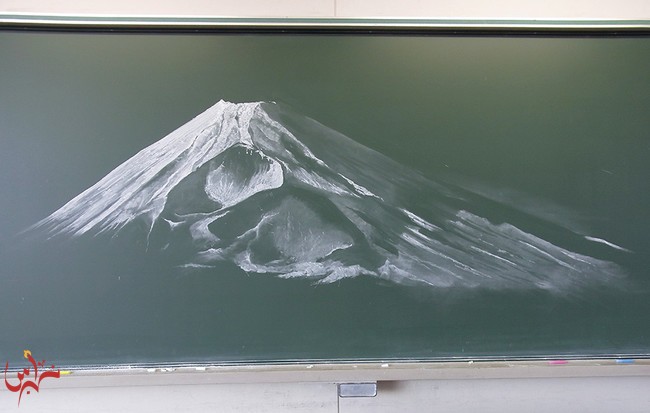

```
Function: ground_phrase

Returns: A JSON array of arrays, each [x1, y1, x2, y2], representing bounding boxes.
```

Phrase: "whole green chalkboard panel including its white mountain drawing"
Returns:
[[0, 30, 650, 366]]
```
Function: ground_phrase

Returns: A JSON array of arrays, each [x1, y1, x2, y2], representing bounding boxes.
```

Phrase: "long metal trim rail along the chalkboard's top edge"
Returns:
[[0, 13, 650, 35]]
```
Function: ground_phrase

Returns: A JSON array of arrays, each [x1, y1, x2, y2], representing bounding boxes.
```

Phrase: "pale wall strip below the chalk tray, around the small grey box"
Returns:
[[0, 377, 650, 413]]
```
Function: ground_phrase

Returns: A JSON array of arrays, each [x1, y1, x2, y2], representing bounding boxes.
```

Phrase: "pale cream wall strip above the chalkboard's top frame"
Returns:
[[0, 0, 650, 20]]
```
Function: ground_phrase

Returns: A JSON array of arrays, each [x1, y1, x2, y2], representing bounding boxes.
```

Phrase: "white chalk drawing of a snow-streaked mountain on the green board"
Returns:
[[33, 101, 621, 291]]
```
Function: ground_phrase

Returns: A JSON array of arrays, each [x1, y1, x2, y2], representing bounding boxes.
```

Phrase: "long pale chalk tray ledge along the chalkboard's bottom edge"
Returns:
[[2, 359, 650, 388]]
